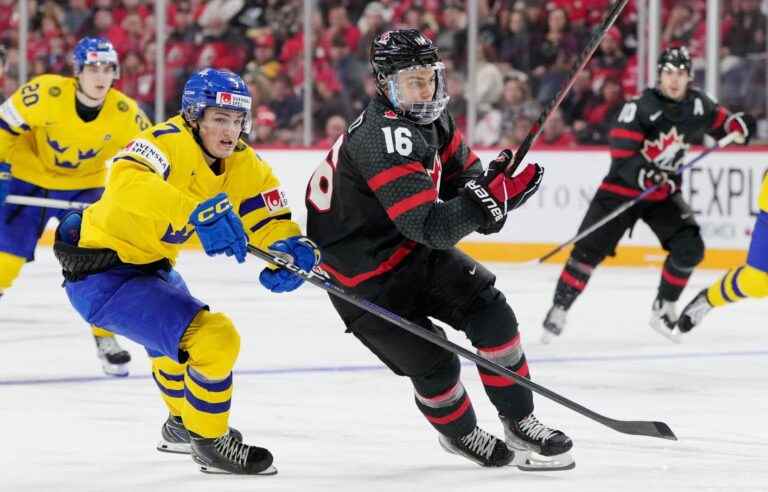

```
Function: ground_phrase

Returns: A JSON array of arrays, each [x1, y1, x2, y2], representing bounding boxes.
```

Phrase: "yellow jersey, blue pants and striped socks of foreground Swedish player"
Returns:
[[66, 116, 300, 437]]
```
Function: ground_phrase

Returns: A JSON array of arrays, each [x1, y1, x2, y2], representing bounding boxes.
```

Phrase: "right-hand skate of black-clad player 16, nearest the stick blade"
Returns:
[[499, 413, 576, 471]]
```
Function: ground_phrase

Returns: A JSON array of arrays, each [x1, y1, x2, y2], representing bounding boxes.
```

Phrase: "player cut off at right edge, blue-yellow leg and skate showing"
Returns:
[[677, 175, 768, 333]]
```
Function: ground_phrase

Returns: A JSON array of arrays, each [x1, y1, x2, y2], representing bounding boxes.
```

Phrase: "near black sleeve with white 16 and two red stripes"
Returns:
[[347, 116, 485, 249]]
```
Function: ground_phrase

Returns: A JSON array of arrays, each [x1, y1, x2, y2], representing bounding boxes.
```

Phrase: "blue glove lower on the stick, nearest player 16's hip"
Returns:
[[259, 236, 320, 292]]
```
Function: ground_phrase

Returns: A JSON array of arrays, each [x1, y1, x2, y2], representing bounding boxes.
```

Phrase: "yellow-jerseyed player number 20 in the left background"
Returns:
[[0, 38, 149, 376]]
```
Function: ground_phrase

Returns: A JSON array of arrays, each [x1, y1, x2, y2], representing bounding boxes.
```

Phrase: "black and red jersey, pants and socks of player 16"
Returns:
[[306, 95, 533, 437]]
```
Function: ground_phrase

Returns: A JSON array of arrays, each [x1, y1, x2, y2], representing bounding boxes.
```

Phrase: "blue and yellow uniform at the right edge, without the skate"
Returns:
[[707, 176, 768, 307]]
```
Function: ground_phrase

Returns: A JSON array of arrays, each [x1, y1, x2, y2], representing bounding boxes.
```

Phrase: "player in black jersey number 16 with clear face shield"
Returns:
[[306, 29, 574, 470]]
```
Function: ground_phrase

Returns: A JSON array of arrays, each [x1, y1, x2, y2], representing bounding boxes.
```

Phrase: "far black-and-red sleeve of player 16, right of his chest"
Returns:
[[440, 114, 483, 200]]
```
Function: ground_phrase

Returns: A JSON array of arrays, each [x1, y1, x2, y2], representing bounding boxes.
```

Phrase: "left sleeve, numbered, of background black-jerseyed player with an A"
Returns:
[[608, 98, 649, 187]]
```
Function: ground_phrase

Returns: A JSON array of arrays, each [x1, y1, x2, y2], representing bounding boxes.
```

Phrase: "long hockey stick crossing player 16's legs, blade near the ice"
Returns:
[[248, 245, 677, 441]]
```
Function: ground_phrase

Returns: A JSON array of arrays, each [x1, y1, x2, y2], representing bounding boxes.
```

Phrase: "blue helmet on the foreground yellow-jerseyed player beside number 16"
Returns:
[[181, 68, 251, 133]]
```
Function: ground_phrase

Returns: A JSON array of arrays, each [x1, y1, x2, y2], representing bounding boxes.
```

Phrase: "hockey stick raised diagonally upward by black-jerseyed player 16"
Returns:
[[506, 0, 629, 175]]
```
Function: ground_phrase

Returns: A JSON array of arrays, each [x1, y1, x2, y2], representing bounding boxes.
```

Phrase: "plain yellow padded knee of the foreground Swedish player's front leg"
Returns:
[[179, 310, 240, 379]]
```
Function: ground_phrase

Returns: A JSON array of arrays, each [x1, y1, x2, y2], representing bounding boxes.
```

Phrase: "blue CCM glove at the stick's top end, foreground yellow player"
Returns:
[[189, 193, 248, 263]]
